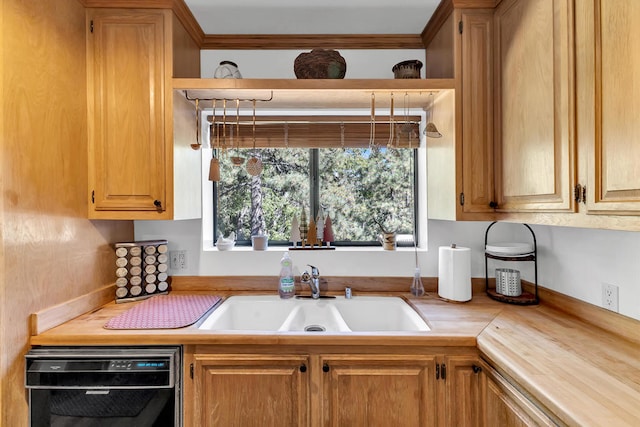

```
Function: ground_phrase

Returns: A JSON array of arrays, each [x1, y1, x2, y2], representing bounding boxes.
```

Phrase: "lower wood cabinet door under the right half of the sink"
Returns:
[[321, 355, 437, 427]]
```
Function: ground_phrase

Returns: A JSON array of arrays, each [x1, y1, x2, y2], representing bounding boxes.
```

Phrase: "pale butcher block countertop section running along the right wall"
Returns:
[[478, 305, 640, 427]]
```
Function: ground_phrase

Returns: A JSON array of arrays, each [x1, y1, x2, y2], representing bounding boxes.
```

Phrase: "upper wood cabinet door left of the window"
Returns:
[[87, 9, 171, 218]]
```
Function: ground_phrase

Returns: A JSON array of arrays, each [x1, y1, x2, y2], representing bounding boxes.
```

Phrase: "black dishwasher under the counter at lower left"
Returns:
[[25, 347, 182, 427]]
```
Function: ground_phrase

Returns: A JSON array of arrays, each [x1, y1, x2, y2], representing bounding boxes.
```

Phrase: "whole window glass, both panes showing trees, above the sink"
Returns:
[[213, 148, 418, 246]]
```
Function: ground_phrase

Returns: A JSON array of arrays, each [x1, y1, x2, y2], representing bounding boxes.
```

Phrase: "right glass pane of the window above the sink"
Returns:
[[318, 148, 414, 243]]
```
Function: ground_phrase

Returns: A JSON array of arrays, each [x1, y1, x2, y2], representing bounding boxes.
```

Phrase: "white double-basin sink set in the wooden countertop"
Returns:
[[199, 295, 429, 333]]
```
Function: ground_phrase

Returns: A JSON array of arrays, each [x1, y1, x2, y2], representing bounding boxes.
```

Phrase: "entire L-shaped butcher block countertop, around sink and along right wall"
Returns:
[[31, 291, 640, 426]]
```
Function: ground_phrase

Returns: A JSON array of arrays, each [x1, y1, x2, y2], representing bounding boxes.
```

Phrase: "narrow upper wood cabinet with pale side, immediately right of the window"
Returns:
[[426, 9, 495, 220]]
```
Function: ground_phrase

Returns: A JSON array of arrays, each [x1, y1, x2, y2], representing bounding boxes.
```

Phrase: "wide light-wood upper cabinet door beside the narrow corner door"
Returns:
[[495, 0, 576, 212]]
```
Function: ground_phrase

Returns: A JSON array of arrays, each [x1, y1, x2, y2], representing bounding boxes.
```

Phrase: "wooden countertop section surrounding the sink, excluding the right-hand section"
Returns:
[[31, 292, 505, 347]]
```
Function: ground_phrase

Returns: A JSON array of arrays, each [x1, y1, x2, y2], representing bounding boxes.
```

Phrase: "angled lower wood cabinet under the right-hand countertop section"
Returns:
[[479, 362, 558, 427]]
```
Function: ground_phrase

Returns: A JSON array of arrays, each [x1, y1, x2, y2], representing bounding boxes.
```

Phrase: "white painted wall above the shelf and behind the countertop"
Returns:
[[135, 50, 640, 319]]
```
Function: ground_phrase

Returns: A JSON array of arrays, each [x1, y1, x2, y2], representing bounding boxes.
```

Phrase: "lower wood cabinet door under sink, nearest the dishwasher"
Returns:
[[193, 354, 309, 427]]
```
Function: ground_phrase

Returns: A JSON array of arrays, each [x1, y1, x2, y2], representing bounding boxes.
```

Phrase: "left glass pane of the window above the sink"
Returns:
[[214, 148, 310, 242]]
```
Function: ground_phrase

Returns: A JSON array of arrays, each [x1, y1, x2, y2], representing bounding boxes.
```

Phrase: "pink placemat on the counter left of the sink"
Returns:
[[104, 295, 221, 329]]
